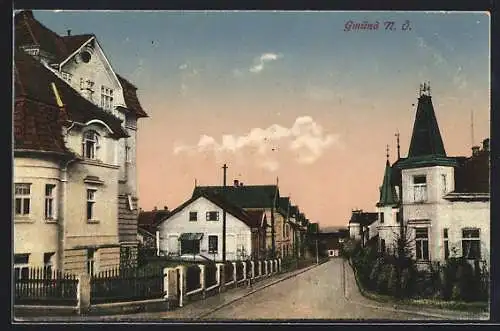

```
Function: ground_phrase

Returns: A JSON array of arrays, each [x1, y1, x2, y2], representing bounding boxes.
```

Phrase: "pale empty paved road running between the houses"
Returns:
[[203, 259, 488, 320]]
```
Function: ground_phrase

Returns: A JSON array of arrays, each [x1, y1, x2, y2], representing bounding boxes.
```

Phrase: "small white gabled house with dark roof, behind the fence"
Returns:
[[157, 192, 265, 261]]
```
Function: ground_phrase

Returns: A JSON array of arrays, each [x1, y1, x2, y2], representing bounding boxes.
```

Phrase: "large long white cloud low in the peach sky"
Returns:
[[173, 116, 338, 171]]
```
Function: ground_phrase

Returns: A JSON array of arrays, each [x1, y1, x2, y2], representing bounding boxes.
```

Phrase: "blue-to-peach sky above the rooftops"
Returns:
[[30, 11, 490, 226]]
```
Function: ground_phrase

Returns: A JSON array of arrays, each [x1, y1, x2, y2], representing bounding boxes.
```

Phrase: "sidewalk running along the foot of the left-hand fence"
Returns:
[[15, 263, 321, 322]]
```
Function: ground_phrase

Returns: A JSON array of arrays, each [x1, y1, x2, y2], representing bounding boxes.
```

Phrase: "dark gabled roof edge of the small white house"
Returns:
[[161, 191, 262, 228]]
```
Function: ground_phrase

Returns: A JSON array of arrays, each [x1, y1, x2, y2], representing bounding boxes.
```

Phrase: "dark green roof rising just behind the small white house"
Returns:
[[193, 185, 279, 208]]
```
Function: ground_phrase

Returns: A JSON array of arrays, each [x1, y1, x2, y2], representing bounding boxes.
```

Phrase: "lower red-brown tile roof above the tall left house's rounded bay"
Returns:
[[14, 50, 128, 152]]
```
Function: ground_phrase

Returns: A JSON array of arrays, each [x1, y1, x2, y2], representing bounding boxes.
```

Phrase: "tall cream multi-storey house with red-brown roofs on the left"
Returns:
[[13, 11, 146, 275]]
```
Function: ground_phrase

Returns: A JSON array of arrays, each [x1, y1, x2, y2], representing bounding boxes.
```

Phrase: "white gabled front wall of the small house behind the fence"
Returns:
[[158, 197, 252, 260]]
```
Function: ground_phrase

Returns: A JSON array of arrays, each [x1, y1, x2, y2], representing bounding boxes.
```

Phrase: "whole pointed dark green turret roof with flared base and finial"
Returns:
[[400, 83, 454, 167]]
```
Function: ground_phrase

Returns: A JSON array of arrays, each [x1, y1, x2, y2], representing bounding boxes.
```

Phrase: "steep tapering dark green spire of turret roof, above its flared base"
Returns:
[[408, 94, 446, 158]]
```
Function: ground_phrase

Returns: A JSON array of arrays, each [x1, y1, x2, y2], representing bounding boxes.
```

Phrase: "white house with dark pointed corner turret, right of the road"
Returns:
[[377, 84, 490, 264]]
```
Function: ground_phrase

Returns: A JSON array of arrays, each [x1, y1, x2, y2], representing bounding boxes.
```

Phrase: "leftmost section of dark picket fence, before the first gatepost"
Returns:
[[14, 267, 78, 306]]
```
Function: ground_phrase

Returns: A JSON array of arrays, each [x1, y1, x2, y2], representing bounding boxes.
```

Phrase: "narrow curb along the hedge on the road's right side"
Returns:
[[342, 261, 491, 320]]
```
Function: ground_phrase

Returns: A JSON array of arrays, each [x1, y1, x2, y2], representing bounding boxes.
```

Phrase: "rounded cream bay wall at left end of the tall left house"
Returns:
[[12, 157, 61, 268]]
